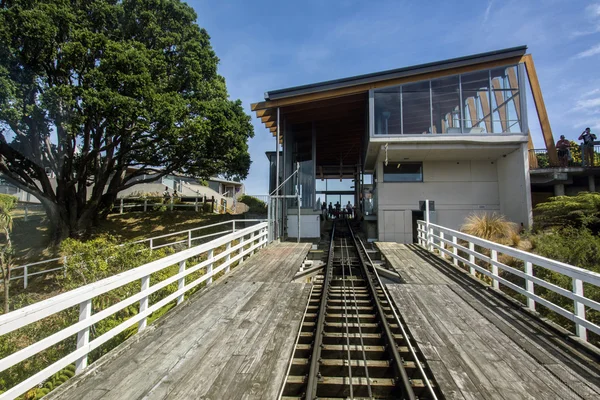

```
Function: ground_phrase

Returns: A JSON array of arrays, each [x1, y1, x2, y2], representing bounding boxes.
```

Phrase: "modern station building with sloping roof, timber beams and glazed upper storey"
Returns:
[[252, 46, 555, 243]]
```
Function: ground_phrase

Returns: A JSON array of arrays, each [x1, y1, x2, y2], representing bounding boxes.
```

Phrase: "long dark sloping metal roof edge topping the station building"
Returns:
[[265, 46, 527, 100]]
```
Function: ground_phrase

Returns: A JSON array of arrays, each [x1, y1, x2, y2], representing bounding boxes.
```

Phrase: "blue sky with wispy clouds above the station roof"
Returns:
[[188, 0, 600, 194]]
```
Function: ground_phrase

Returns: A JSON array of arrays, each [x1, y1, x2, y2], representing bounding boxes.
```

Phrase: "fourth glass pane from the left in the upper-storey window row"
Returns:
[[461, 70, 492, 133]]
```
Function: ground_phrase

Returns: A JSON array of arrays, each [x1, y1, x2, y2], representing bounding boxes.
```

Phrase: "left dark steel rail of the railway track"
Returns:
[[306, 221, 335, 400]]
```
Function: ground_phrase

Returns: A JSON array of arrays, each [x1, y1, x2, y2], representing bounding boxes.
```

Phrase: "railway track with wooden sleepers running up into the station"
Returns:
[[280, 221, 443, 400]]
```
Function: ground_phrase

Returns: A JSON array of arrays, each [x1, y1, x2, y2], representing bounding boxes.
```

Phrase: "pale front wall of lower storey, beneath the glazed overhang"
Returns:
[[377, 160, 500, 243]]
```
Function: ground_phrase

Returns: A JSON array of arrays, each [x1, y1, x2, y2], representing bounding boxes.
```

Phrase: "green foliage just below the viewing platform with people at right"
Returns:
[[534, 192, 600, 234]]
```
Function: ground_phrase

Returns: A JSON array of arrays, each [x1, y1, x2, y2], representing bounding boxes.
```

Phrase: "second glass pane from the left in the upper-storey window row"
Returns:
[[402, 81, 431, 134]]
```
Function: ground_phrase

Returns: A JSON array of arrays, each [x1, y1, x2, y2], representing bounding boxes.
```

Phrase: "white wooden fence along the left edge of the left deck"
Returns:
[[0, 222, 267, 400]]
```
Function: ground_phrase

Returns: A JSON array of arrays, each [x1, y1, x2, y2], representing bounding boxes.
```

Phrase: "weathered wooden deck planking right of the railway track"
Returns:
[[377, 243, 600, 399]]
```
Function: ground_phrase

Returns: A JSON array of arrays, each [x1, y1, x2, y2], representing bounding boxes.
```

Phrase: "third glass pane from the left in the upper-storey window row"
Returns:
[[431, 75, 461, 134]]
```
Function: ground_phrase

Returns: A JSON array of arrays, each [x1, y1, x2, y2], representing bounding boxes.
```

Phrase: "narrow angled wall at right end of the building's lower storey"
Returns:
[[498, 143, 532, 227]]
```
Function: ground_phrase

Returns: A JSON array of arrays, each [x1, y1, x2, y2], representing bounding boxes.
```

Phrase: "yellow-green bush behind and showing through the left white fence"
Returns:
[[0, 236, 173, 398]]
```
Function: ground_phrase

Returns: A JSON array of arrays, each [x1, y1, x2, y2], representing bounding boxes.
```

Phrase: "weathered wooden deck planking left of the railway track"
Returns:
[[49, 243, 310, 400]]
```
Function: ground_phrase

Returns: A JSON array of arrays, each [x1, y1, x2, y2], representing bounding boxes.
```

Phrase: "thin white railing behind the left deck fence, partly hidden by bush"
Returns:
[[0, 219, 263, 289]]
